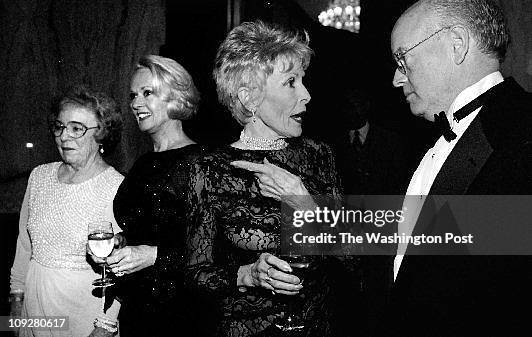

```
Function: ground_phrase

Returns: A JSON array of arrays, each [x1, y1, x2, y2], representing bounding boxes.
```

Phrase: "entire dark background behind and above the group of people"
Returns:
[[0, 0, 532, 315]]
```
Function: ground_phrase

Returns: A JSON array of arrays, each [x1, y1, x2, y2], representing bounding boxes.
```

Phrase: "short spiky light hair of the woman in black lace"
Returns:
[[213, 21, 313, 125]]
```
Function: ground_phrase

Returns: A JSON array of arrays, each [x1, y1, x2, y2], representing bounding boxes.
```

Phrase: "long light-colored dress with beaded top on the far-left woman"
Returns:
[[11, 162, 124, 337]]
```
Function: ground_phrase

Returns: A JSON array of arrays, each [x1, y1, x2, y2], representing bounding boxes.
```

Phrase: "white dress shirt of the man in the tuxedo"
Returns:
[[393, 71, 504, 280]]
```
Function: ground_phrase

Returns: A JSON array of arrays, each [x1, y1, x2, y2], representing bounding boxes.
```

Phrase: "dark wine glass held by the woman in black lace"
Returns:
[[274, 255, 311, 337]]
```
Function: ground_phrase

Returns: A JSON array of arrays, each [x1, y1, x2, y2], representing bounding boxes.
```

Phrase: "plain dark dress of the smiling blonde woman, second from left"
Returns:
[[110, 144, 204, 337]]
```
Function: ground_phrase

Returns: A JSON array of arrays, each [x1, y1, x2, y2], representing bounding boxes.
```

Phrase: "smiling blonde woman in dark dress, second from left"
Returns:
[[102, 55, 206, 337]]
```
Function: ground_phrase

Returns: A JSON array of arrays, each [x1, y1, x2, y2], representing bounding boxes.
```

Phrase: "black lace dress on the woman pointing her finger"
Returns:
[[185, 138, 339, 337]]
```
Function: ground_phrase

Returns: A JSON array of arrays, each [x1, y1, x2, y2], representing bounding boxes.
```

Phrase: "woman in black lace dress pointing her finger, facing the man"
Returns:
[[185, 22, 338, 337]]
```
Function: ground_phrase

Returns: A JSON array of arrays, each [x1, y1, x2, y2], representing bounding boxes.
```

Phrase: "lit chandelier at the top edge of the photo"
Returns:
[[318, 0, 360, 33]]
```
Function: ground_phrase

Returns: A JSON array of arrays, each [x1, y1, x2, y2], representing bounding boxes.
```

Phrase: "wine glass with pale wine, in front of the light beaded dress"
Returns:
[[89, 221, 114, 287]]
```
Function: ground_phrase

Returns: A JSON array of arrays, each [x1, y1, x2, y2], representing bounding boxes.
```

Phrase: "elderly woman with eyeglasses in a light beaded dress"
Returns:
[[10, 87, 123, 336]]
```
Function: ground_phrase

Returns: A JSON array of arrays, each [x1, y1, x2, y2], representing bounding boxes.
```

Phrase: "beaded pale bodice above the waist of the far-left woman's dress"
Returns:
[[28, 162, 123, 270]]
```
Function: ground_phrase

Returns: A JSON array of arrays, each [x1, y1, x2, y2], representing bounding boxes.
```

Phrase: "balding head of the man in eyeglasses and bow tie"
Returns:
[[391, 0, 509, 120]]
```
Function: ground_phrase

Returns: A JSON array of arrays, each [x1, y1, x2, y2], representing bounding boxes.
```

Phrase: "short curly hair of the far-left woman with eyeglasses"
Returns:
[[51, 85, 123, 156]]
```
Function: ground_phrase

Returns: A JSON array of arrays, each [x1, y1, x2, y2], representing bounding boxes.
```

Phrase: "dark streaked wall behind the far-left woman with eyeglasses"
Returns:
[[0, 0, 166, 315]]
